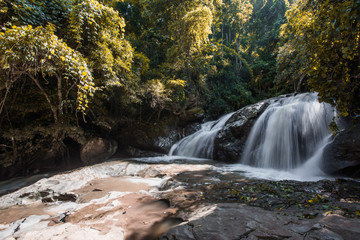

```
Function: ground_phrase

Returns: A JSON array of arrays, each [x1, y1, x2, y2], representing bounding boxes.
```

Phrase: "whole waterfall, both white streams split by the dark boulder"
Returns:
[[169, 93, 334, 175]]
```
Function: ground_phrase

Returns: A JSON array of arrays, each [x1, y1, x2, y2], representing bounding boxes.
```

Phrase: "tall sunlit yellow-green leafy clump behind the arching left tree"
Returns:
[[68, 0, 133, 88]]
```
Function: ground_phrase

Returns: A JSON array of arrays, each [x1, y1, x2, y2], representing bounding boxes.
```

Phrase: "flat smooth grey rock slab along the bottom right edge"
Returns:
[[160, 203, 360, 240]]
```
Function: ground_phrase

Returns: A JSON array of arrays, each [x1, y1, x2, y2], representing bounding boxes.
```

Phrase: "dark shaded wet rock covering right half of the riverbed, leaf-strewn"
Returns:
[[160, 170, 360, 240]]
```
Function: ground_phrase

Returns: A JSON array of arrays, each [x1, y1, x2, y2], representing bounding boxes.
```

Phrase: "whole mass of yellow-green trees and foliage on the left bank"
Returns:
[[0, 0, 136, 170]]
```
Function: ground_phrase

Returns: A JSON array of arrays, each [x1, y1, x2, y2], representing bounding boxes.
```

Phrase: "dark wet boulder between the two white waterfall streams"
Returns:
[[213, 99, 273, 163]]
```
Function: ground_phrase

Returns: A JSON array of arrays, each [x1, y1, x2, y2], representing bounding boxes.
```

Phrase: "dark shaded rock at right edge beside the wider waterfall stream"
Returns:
[[323, 120, 360, 177]]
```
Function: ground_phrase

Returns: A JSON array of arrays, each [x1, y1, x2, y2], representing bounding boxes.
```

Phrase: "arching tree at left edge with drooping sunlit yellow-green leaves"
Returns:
[[0, 25, 96, 167]]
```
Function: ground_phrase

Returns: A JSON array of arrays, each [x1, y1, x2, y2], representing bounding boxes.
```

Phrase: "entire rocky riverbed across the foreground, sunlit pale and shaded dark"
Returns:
[[0, 160, 360, 240]]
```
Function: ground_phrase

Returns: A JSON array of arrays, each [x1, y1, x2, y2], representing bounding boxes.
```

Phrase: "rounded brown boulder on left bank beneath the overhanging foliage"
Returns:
[[80, 138, 117, 165]]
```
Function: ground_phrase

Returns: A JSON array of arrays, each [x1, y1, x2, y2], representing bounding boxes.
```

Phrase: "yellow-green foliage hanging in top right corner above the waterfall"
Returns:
[[278, 0, 360, 116]]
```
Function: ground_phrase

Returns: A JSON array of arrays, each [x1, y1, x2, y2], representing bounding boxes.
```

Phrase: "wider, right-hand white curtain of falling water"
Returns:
[[241, 93, 334, 170]]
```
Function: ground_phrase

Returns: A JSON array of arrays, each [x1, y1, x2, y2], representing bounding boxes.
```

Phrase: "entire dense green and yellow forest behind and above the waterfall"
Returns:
[[0, 0, 360, 176]]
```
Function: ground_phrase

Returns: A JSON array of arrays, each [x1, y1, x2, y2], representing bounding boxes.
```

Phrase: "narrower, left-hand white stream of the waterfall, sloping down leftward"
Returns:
[[169, 113, 233, 159]]
